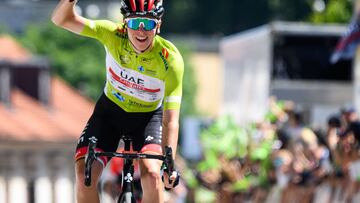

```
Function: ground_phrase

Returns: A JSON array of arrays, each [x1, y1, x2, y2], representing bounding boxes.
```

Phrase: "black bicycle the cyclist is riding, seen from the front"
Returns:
[[84, 136, 175, 203]]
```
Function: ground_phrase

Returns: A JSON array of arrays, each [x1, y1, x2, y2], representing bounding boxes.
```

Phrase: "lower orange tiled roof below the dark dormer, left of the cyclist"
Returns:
[[0, 77, 93, 141]]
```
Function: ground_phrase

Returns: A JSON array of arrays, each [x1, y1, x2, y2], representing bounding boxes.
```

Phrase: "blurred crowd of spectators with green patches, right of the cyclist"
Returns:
[[98, 99, 360, 203]]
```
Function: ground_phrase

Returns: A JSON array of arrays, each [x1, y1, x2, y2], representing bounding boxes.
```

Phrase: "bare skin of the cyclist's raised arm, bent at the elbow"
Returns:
[[51, 0, 85, 34]]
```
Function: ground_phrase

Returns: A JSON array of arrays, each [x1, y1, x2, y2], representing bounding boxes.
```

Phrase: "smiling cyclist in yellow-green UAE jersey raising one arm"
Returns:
[[52, 0, 184, 203]]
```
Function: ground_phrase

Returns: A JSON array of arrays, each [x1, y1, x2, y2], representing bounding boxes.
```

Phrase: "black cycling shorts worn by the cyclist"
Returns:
[[75, 94, 163, 165]]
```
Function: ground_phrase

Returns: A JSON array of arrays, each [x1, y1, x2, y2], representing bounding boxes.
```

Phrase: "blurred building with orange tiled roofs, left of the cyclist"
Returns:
[[0, 36, 93, 203]]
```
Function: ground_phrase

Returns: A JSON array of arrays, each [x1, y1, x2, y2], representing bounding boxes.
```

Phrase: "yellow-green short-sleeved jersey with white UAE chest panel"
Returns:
[[80, 19, 184, 112]]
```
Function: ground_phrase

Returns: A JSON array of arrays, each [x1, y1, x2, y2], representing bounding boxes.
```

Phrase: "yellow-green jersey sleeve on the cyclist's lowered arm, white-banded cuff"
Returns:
[[164, 51, 184, 110]]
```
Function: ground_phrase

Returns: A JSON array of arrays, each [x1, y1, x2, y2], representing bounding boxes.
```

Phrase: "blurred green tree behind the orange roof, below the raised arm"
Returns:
[[19, 24, 105, 99]]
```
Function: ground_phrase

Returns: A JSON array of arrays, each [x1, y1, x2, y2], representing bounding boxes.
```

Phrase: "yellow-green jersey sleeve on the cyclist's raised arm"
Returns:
[[80, 19, 118, 43]]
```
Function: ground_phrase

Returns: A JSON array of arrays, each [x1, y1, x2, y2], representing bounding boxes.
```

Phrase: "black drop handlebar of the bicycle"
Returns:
[[84, 138, 174, 186]]
